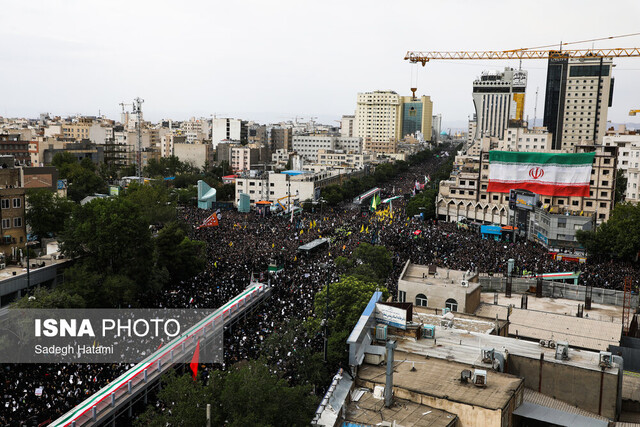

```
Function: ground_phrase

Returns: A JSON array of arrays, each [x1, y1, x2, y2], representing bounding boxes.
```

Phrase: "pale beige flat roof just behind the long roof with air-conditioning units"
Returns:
[[475, 298, 622, 351]]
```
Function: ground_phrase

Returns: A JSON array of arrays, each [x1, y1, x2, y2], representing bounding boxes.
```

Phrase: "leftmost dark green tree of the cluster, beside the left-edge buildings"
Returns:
[[25, 188, 74, 238]]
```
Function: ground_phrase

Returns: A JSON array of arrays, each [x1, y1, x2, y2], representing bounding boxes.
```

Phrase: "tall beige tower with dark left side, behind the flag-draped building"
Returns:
[[543, 52, 614, 149]]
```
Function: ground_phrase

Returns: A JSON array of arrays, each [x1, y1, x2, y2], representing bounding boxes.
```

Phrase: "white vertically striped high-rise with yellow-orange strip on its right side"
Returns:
[[473, 67, 527, 139]]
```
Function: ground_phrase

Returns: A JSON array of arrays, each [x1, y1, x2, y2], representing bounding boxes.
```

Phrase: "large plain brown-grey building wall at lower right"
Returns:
[[506, 352, 618, 419]]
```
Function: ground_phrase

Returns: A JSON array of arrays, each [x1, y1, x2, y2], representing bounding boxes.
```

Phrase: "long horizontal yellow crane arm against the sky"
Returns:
[[404, 47, 640, 66]]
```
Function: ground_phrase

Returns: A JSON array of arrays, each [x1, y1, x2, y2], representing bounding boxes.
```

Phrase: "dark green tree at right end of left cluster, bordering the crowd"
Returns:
[[155, 222, 205, 281]]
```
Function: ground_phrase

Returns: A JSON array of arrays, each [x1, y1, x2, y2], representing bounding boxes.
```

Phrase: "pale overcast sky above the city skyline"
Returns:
[[0, 0, 640, 129]]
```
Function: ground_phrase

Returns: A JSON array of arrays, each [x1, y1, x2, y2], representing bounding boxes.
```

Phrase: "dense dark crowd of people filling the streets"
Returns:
[[0, 149, 638, 425]]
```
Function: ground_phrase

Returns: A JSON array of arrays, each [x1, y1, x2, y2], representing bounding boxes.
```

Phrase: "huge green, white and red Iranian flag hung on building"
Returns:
[[487, 151, 595, 197]]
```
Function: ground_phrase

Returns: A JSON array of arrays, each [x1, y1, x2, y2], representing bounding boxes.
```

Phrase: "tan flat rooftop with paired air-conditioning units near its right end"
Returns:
[[357, 352, 524, 410]]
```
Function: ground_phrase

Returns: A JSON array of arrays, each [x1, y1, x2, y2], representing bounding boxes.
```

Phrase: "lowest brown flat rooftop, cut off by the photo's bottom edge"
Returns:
[[345, 389, 458, 427]]
